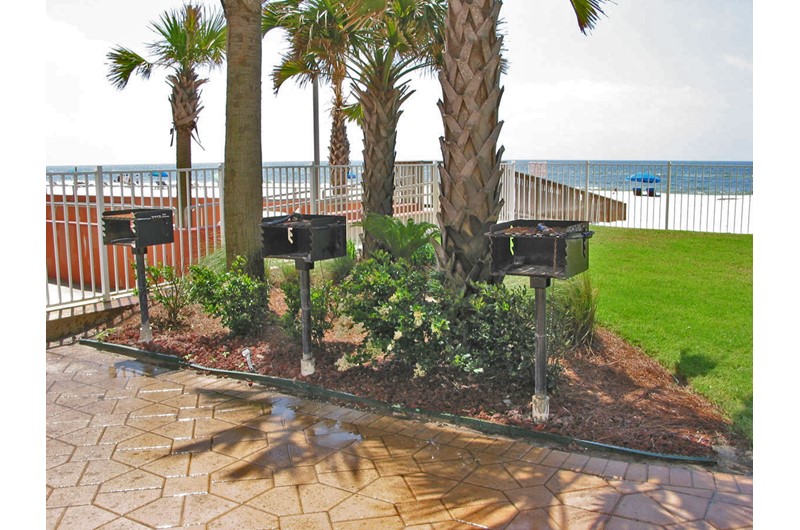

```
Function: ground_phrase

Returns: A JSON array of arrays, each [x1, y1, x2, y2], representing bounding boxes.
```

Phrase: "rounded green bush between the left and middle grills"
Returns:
[[189, 256, 269, 335]]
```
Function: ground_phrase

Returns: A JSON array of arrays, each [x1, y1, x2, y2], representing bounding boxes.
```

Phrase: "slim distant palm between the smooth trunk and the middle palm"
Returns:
[[262, 0, 358, 190]]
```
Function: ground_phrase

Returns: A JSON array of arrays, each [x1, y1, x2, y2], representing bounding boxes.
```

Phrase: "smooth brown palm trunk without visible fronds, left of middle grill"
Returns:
[[222, 0, 264, 278]]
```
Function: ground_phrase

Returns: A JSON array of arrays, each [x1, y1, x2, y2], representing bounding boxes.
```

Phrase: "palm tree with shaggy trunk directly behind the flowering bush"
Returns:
[[352, 0, 446, 252]]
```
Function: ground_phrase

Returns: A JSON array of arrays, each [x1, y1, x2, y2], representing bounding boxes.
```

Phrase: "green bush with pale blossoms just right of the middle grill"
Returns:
[[337, 250, 449, 370]]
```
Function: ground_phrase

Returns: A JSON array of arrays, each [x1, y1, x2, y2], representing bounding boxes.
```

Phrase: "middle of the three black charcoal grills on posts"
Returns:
[[261, 214, 347, 375]]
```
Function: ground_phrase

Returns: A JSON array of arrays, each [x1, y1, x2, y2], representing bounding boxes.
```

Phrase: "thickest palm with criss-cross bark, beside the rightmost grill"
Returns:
[[436, 0, 605, 288]]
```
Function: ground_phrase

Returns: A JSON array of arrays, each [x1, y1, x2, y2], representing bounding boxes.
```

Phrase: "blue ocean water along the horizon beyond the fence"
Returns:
[[47, 160, 753, 195]]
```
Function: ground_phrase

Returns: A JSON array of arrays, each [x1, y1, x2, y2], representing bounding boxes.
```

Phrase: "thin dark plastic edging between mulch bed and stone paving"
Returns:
[[79, 339, 716, 465]]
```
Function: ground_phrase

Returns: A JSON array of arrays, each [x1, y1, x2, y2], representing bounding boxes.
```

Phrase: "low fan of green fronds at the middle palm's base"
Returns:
[[356, 209, 439, 263]]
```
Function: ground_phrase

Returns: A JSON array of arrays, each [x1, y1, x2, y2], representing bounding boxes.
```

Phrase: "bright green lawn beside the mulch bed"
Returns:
[[514, 227, 753, 441]]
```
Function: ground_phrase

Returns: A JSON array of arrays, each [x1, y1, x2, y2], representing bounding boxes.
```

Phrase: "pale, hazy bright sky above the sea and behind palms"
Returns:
[[44, 0, 753, 165]]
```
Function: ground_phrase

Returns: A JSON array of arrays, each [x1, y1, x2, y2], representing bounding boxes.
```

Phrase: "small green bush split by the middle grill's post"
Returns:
[[280, 275, 333, 345]]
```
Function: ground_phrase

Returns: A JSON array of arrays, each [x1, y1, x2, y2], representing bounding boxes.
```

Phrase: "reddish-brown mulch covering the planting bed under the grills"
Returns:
[[102, 290, 752, 472]]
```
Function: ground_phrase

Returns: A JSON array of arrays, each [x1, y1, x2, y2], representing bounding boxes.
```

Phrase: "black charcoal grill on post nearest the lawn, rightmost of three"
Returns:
[[486, 219, 594, 422]]
